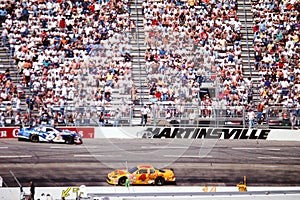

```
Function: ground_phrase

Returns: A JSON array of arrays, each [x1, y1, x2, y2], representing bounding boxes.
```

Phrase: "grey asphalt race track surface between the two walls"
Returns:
[[0, 139, 300, 187]]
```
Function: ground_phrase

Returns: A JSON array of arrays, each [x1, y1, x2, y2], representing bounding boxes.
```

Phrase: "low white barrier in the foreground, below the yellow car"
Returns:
[[0, 186, 300, 200]]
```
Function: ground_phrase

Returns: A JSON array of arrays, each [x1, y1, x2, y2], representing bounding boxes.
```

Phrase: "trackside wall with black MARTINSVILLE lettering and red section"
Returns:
[[0, 127, 300, 141]]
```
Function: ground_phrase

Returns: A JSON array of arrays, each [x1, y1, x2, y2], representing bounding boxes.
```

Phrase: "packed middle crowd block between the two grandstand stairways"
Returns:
[[143, 0, 253, 120]]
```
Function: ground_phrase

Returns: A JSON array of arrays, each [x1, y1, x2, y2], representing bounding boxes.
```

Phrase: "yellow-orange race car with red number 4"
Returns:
[[106, 165, 176, 185]]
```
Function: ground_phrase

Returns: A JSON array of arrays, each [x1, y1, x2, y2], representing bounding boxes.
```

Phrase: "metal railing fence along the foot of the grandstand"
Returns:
[[2, 102, 300, 128]]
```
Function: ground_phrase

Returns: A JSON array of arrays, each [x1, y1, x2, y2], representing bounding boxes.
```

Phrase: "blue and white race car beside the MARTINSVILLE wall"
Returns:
[[18, 125, 82, 144]]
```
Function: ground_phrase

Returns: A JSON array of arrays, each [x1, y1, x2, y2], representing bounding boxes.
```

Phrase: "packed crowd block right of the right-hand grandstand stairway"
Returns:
[[252, 0, 300, 125]]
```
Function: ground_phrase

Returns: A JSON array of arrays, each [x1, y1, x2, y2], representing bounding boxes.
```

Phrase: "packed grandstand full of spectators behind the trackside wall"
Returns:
[[0, 0, 300, 128]]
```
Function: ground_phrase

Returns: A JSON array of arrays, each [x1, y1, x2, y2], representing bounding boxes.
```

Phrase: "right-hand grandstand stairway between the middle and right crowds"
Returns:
[[237, 0, 260, 103]]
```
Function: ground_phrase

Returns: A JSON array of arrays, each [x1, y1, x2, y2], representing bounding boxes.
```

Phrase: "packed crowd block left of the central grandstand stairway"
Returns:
[[0, 0, 132, 125]]
